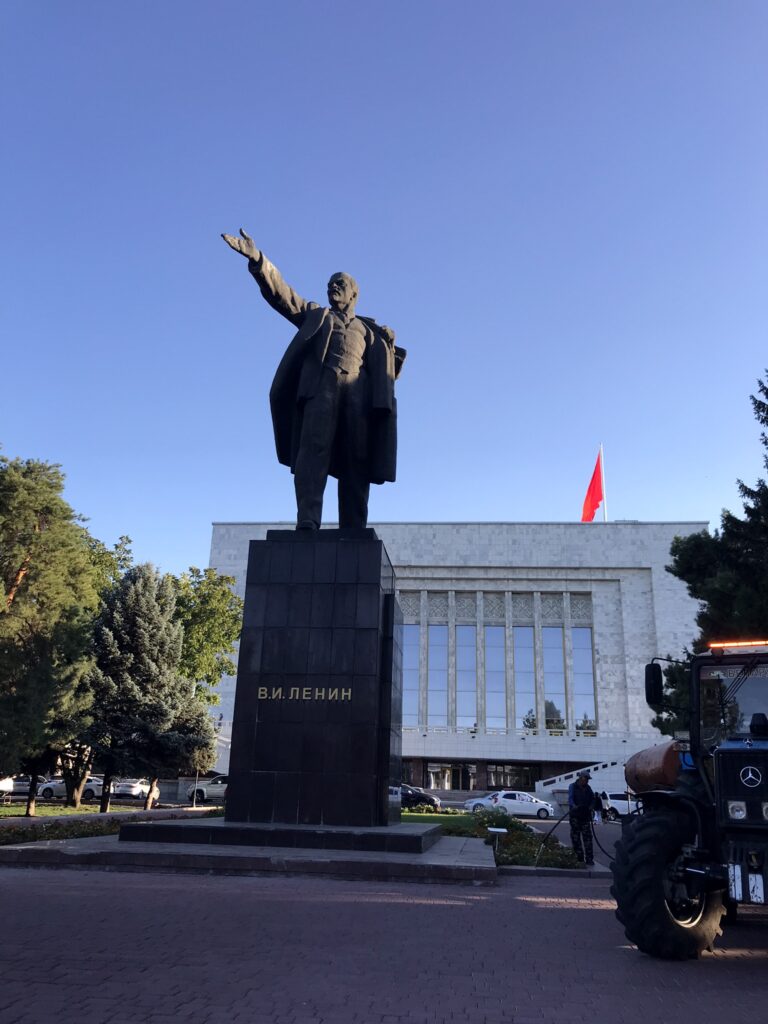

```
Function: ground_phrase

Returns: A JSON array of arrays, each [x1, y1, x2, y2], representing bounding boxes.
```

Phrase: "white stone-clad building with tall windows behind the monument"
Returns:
[[210, 521, 707, 790]]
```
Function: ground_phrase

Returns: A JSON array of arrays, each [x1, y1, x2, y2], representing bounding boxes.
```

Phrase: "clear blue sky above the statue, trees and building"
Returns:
[[0, 0, 768, 571]]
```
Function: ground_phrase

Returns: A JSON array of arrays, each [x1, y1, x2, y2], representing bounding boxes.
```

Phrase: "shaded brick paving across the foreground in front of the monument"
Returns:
[[0, 868, 768, 1024]]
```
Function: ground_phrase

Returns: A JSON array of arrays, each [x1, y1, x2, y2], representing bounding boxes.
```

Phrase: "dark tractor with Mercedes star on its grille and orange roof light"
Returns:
[[610, 640, 768, 959]]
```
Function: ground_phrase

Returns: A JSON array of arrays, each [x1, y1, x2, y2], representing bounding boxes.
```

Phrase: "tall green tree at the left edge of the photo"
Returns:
[[0, 457, 99, 814]]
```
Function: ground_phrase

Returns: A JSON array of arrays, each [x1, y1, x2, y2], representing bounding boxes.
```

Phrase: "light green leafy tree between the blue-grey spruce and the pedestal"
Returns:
[[175, 566, 243, 705]]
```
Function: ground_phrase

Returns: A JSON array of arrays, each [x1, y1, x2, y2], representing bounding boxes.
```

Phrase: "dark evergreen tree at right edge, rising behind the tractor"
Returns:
[[653, 371, 768, 734]]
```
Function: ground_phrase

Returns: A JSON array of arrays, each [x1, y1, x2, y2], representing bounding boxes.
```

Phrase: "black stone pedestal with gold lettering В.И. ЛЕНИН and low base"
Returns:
[[121, 529, 409, 853]]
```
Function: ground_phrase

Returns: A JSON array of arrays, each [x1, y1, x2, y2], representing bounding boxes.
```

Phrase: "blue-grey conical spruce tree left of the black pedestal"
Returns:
[[84, 564, 215, 810]]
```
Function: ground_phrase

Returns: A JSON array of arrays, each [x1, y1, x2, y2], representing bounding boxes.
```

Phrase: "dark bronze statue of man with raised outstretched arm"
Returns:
[[221, 228, 406, 529]]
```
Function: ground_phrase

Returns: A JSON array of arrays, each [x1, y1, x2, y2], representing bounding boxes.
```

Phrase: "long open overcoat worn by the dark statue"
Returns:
[[248, 254, 406, 483]]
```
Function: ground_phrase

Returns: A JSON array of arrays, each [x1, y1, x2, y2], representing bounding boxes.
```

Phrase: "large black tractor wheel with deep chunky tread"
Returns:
[[610, 811, 725, 959]]
